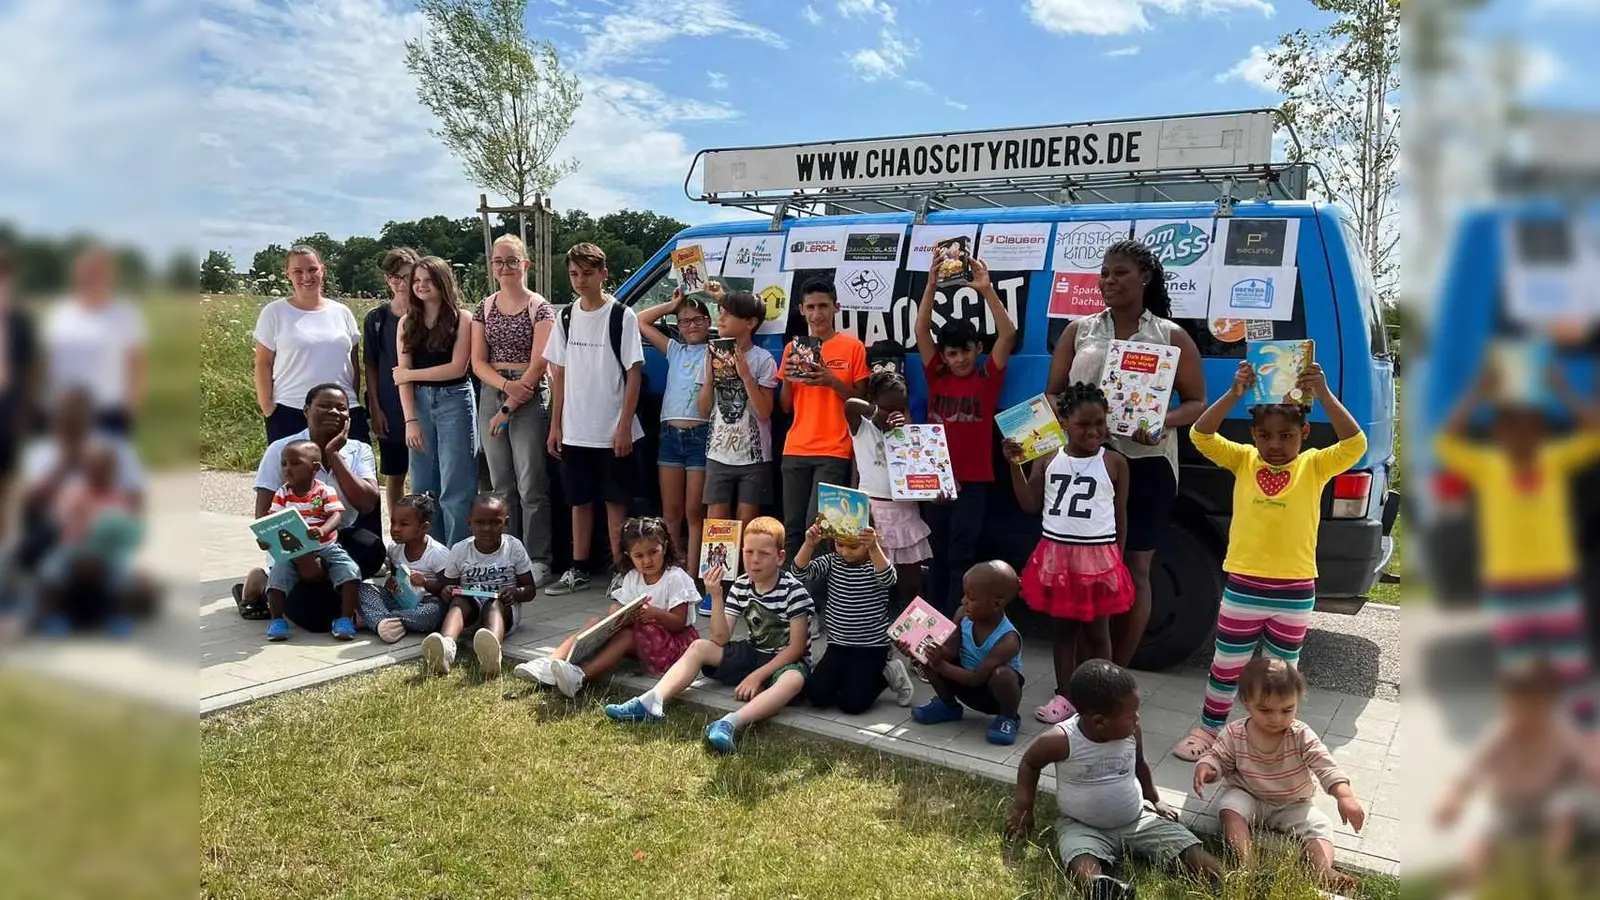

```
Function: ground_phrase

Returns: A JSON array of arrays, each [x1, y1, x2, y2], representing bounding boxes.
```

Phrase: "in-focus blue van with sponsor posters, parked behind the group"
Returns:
[[598, 200, 1397, 669]]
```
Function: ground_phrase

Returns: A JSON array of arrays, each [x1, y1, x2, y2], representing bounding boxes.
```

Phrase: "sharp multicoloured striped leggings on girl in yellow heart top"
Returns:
[[1200, 573, 1317, 733]]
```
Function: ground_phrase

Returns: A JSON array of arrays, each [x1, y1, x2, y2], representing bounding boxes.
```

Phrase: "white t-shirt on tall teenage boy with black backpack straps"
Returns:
[[544, 301, 645, 448]]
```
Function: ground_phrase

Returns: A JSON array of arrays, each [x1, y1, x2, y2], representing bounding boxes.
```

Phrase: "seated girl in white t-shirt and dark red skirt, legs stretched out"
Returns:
[[512, 519, 699, 697]]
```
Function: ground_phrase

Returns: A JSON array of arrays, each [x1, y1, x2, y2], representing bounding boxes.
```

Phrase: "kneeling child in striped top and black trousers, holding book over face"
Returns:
[[794, 524, 914, 716]]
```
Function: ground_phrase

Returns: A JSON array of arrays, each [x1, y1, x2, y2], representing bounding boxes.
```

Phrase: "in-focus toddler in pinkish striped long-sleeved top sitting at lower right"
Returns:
[[1195, 657, 1366, 892]]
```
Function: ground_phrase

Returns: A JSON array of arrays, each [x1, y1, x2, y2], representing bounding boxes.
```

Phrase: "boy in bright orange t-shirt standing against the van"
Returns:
[[778, 279, 872, 559]]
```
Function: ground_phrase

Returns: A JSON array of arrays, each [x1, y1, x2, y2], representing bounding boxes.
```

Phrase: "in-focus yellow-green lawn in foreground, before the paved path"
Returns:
[[200, 663, 1397, 900]]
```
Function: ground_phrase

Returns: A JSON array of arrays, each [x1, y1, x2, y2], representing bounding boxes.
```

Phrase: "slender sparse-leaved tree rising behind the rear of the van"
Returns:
[[1267, 0, 1400, 303]]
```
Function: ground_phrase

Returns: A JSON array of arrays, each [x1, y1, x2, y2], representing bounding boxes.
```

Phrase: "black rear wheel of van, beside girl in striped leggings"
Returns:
[[1133, 524, 1222, 671]]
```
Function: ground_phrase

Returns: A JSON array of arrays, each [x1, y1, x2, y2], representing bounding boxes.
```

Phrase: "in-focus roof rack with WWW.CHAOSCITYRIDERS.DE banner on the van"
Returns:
[[683, 109, 1331, 229]]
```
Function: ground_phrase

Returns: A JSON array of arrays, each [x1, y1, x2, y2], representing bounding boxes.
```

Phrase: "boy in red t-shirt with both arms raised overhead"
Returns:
[[917, 259, 1016, 615]]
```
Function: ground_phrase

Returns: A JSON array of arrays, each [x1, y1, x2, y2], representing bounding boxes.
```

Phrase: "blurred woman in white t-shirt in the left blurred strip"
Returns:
[[40, 243, 146, 437]]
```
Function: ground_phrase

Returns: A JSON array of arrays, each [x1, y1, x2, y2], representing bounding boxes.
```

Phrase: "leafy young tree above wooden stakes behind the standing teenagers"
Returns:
[[405, 0, 584, 240]]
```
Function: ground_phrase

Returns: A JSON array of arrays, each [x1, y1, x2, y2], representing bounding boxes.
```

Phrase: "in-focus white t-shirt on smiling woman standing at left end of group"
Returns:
[[254, 299, 362, 410]]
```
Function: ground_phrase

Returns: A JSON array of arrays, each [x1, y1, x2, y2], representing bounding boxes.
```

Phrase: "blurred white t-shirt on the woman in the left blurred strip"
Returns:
[[40, 298, 145, 412]]
